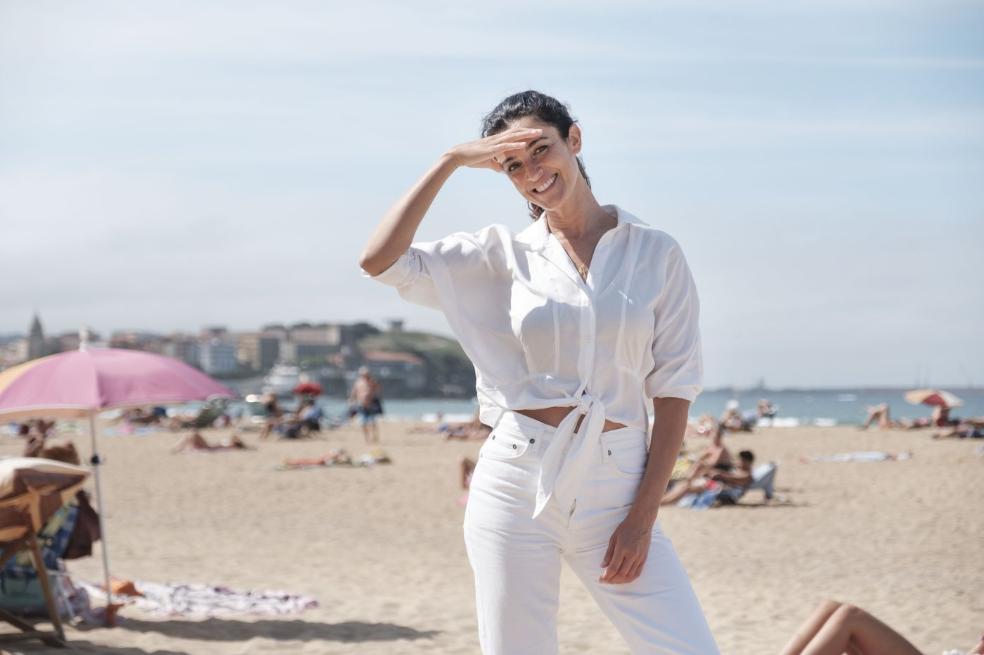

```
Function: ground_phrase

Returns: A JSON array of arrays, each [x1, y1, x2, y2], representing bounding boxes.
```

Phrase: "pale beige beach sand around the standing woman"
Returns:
[[0, 423, 984, 655]]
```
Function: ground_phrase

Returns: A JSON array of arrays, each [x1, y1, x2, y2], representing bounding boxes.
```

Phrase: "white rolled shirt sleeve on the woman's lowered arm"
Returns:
[[645, 243, 704, 402]]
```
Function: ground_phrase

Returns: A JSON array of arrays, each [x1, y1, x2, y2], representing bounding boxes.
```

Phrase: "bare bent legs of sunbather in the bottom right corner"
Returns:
[[780, 600, 984, 655]]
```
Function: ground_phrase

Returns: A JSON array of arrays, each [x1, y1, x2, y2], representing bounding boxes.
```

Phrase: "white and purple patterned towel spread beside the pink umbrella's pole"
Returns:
[[83, 582, 318, 618]]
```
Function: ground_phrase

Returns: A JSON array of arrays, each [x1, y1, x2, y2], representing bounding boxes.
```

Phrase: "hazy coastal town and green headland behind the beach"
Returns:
[[0, 313, 475, 398]]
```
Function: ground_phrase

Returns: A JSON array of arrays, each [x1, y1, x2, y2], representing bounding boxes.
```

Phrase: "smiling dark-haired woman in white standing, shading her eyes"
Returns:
[[360, 91, 718, 655]]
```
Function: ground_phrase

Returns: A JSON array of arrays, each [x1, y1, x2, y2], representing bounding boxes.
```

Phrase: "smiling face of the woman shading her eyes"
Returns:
[[499, 116, 583, 211]]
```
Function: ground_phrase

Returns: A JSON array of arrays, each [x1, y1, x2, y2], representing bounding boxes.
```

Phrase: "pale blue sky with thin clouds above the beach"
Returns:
[[0, 0, 984, 387]]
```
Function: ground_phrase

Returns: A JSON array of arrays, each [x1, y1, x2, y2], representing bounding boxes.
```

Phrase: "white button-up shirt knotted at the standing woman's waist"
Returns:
[[363, 206, 703, 513]]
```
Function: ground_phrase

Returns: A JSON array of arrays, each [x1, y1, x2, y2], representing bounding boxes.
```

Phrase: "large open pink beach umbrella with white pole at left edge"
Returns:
[[0, 345, 235, 617]]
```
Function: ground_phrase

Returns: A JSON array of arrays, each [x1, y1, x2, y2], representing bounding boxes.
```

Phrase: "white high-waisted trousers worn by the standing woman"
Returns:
[[464, 412, 718, 655]]
